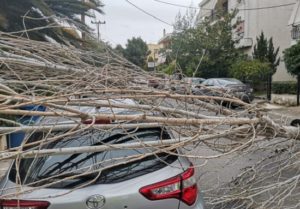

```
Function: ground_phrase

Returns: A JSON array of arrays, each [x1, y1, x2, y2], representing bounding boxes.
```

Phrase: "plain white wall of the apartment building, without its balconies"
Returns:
[[201, 0, 297, 81]]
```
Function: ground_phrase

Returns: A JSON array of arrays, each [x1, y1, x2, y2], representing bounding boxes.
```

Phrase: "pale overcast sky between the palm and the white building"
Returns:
[[94, 0, 201, 46]]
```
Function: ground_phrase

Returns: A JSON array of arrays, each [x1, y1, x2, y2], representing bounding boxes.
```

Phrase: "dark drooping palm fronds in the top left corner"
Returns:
[[0, 0, 103, 45]]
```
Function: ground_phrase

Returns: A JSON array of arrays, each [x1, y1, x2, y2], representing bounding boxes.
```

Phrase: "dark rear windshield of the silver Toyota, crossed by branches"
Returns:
[[9, 128, 177, 188]]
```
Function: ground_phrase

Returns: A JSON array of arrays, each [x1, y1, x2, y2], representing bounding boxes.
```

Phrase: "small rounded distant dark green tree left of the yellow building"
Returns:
[[123, 37, 150, 68]]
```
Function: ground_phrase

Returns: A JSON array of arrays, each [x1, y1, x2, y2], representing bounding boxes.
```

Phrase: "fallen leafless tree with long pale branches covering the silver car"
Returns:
[[0, 33, 300, 208]]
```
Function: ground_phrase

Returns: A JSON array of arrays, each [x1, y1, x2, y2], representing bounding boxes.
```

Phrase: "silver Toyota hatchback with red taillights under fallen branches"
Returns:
[[0, 117, 204, 209]]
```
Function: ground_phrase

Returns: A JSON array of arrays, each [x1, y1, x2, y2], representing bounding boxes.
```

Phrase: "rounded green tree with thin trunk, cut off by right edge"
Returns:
[[284, 42, 300, 106]]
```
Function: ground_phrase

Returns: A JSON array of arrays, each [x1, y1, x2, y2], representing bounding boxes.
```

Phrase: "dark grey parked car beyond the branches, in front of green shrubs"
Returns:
[[194, 78, 253, 103]]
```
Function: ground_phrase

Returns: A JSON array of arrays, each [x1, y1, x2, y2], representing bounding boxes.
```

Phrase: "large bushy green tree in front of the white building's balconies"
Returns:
[[171, 10, 240, 78]]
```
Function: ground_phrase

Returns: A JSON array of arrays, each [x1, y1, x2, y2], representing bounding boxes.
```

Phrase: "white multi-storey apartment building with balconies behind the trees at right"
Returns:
[[198, 0, 294, 81]]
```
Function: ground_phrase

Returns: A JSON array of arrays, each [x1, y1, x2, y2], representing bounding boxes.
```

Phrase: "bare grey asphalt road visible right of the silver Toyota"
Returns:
[[190, 103, 300, 207]]
